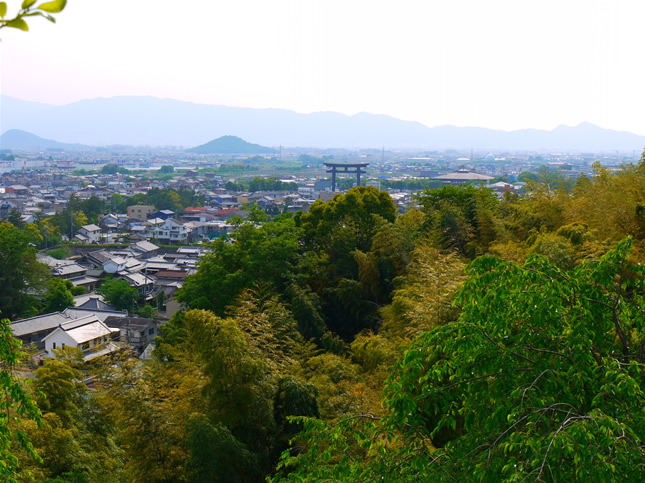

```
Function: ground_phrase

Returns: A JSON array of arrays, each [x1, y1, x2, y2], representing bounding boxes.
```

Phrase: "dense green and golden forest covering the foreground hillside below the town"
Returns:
[[0, 158, 645, 482]]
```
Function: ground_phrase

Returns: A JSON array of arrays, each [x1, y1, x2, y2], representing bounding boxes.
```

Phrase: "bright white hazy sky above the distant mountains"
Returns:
[[0, 0, 645, 135]]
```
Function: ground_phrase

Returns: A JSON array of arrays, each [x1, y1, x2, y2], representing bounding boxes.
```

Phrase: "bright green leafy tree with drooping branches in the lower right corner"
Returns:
[[282, 239, 645, 481]]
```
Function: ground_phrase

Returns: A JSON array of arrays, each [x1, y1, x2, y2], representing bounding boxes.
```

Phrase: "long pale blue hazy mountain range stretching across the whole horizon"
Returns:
[[0, 96, 645, 152]]
